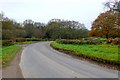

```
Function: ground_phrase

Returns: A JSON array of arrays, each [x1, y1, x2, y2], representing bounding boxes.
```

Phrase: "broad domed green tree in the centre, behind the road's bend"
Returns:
[[46, 19, 88, 39]]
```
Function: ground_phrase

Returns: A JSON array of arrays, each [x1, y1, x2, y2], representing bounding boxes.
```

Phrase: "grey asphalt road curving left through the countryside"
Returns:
[[20, 42, 118, 78]]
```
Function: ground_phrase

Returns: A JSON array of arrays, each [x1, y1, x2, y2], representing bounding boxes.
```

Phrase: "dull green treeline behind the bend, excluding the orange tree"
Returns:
[[1, 16, 88, 40]]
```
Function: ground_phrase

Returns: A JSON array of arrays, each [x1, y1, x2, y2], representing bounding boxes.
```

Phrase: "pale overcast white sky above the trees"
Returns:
[[0, 0, 108, 29]]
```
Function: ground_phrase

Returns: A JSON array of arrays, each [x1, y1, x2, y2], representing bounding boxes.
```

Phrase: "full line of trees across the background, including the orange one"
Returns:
[[0, 6, 120, 40]]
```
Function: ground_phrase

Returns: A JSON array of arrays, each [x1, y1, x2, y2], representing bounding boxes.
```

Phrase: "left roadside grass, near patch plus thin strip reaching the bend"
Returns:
[[0, 39, 48, 67]]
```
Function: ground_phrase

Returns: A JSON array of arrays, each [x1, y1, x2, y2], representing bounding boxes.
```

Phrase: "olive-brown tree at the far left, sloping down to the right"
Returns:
[[1, 16, 26, 40]]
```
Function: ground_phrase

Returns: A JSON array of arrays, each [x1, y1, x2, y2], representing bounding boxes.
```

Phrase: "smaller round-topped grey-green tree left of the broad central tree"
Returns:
[[23, 19, 46, 38]]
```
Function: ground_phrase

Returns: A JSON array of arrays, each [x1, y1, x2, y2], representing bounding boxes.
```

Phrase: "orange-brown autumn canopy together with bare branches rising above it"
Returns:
[[89, 0, 120, 38]]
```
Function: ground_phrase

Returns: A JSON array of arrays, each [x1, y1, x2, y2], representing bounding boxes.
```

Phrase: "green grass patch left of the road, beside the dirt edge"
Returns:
[[2, 45, 21, 67]]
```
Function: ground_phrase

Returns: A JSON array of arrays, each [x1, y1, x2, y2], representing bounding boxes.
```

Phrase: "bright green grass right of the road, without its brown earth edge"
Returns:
[[51, 42, 118, 62]]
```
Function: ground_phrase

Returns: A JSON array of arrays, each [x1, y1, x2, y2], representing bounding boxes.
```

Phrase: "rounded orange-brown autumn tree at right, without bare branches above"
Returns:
[[89, 11, 120, 38]]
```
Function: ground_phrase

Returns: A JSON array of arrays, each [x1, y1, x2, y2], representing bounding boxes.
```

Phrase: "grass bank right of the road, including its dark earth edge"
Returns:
[[50, 42, 120, 70]]
